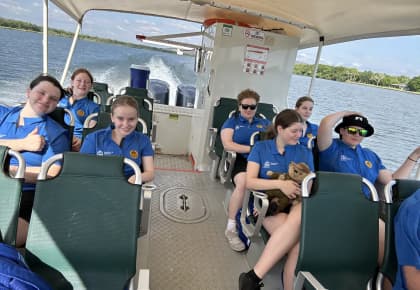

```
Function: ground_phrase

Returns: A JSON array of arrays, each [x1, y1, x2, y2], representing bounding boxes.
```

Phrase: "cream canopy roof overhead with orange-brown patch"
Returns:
[[50, 0, 420, 48]]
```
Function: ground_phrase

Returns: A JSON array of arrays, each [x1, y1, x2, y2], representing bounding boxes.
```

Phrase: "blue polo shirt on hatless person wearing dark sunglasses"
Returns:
[[221, 113, 271, 158]]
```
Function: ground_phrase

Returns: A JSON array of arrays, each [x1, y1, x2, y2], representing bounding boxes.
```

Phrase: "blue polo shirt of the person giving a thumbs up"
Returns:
[[0, 106, 69, 190]]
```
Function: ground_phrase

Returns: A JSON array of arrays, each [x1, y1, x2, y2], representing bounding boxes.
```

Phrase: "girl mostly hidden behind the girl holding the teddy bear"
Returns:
[[295, 96, 318, 148]]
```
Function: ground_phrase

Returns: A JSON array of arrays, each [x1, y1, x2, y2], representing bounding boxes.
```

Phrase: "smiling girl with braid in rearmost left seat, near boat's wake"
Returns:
[[58, 68, 99, 151]]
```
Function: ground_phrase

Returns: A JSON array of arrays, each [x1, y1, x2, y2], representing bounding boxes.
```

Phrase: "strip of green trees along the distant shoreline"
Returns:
[[0, 17, 420, 93]]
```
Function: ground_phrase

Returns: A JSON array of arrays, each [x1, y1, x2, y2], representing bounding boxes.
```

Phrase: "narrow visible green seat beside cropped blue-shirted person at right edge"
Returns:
[[376, 179, 420, 290]]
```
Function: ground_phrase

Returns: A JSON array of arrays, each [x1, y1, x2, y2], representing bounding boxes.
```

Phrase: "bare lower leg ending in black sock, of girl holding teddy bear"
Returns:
[[254, 203, 302, 278]]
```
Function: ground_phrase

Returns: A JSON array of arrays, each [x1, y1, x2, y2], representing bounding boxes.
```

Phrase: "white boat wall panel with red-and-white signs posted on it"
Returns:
[[190, 23, 299, 171]]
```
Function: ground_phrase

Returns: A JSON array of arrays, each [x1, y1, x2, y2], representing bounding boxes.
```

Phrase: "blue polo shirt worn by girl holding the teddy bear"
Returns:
[[248, 138, 314, 179]]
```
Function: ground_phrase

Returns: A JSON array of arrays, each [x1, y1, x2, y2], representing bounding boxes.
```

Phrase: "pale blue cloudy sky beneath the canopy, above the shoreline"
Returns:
[[0, 0, 420, 77]]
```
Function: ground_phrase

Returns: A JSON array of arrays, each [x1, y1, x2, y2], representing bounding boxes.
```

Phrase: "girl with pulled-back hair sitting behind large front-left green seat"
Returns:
[[80, 96, 154, 182]]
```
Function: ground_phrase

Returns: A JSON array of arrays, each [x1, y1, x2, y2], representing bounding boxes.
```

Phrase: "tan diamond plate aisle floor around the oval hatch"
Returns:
[[139, 155, 249, 290]]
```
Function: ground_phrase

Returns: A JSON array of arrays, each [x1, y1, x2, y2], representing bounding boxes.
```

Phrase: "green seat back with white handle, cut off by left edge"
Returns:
[[0, 146, 25, 245]]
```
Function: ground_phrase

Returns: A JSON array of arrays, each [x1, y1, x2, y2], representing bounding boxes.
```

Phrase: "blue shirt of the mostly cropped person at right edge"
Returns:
[[392, 189, 420, 290]]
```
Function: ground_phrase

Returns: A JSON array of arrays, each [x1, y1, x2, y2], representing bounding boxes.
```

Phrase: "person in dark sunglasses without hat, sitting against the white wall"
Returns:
[[220, 89, 270, 252]]
